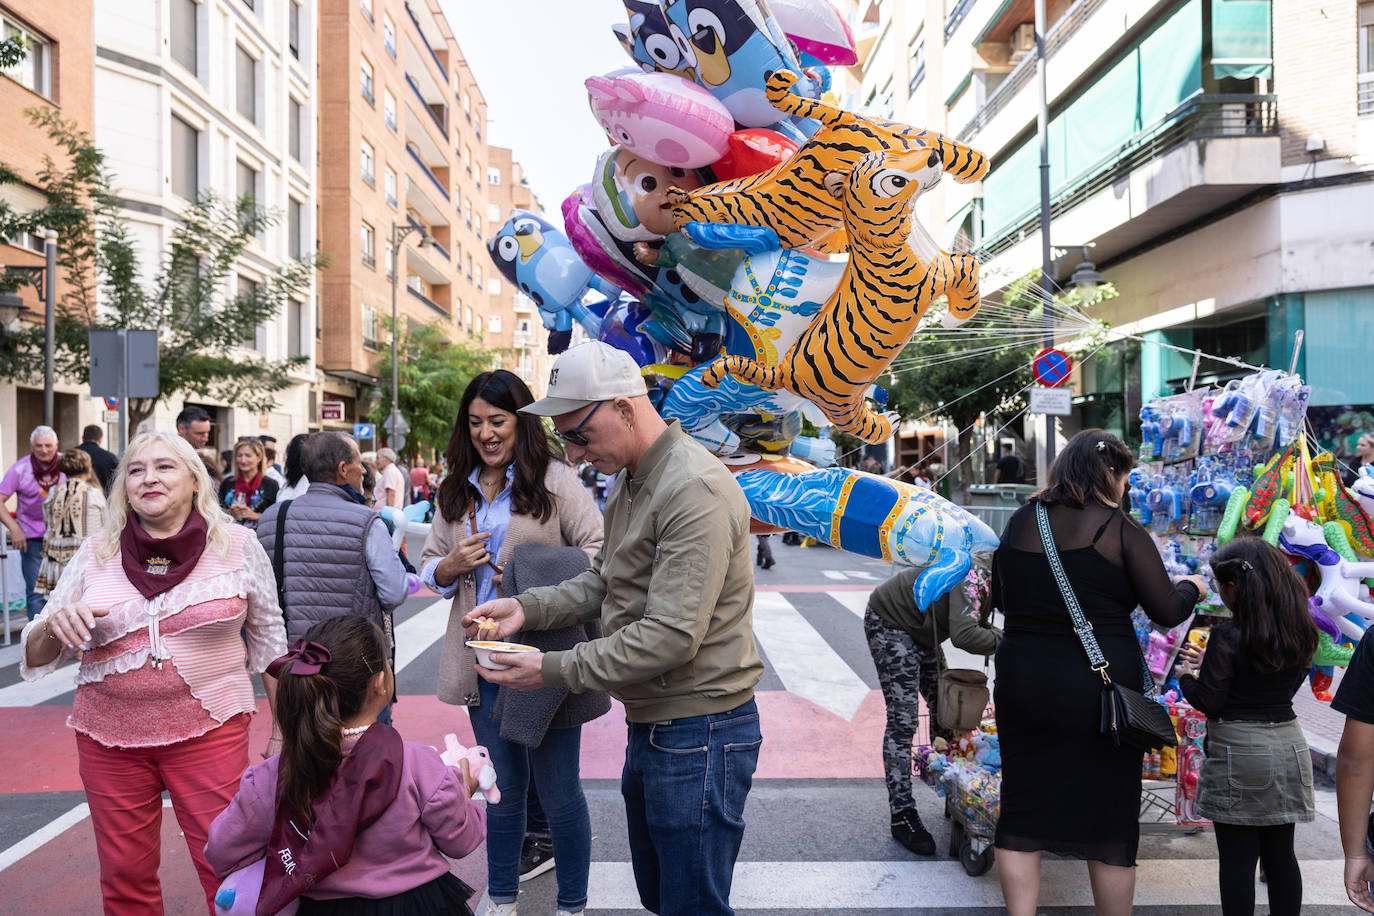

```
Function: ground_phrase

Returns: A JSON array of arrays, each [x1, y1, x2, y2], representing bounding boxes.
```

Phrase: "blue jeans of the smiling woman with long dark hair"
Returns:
[[467, 681, 592, 912]]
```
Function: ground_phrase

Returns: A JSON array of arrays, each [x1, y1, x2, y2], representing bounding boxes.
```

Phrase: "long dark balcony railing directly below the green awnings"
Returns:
[[978, 95, 1278, 260]]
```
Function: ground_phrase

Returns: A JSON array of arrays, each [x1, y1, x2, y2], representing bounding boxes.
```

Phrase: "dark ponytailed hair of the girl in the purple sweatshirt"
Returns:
[[268, 615, 386, 823]]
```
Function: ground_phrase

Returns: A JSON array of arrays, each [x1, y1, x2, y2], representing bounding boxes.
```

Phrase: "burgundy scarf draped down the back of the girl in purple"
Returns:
[[257, 724, 404, 916]]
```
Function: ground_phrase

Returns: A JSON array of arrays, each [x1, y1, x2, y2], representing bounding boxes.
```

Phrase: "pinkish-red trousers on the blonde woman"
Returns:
[[77, 714, 249, 916]]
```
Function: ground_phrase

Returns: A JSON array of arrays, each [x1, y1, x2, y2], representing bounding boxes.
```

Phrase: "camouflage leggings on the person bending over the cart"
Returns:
[[863, 607, 944, 814]]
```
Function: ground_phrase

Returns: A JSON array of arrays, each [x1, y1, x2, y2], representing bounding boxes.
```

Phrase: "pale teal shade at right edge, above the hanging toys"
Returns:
[[1303, 286, 1374, 407]]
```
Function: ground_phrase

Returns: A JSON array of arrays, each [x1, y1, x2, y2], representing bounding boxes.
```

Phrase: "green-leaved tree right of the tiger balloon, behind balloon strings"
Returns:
[[888, 271, 1117, 490]]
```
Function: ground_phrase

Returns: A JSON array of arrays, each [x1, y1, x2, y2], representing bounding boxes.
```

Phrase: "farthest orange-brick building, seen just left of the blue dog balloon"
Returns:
[[484, 147, 552, 397]]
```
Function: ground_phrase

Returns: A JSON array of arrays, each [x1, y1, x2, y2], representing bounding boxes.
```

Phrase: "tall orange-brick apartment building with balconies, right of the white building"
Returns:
[[311, 0, 514, 439]]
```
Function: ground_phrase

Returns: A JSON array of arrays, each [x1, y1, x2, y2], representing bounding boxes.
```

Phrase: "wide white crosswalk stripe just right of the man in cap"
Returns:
[[754, 592, 868, 721]]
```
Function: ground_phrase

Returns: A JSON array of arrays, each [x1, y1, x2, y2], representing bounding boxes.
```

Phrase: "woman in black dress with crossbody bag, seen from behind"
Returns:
[[992, 430, 1206, 916]]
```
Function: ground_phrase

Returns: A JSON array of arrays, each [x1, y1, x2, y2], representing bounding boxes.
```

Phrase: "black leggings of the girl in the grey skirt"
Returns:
[[1213, 823, 1303, 916]]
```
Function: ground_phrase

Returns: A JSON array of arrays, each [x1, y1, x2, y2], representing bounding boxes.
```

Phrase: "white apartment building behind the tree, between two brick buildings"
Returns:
[[92, 0, 317, 449]]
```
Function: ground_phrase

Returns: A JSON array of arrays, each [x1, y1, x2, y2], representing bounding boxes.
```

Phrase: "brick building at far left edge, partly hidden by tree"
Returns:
[[0, 0, 100, 466]]
